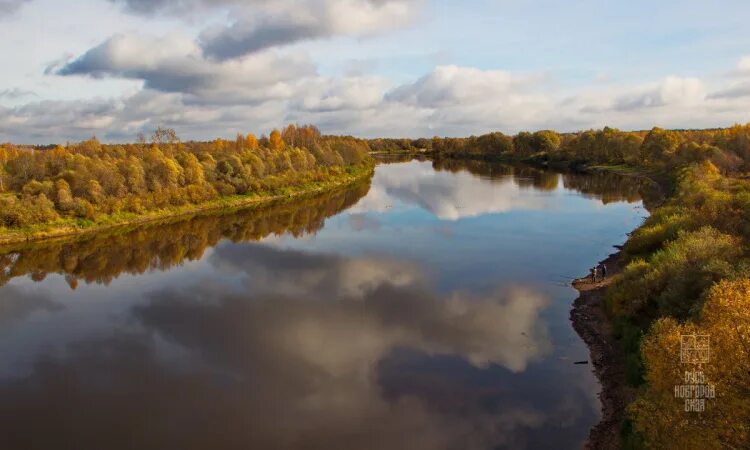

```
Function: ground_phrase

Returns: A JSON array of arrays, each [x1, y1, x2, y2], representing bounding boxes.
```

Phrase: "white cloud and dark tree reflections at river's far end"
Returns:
[[355, 160, 646, 220]]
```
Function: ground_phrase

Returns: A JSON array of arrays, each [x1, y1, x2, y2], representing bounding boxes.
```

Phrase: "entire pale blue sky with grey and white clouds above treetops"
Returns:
[[0, 0, 750, 144]]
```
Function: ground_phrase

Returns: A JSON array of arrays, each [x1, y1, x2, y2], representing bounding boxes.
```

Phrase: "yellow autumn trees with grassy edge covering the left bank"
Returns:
[[0, 125, 373, 244]]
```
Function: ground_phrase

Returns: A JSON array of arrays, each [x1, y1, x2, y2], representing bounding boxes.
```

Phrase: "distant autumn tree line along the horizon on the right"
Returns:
[[376, 124, 750, 171]]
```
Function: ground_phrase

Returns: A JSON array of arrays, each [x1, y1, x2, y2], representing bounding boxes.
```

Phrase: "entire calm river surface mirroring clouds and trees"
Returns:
[[0, 161, 645, 449]]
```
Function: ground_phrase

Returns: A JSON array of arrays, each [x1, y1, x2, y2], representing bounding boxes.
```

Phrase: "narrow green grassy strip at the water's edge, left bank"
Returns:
[[0, 166, 374, 245]]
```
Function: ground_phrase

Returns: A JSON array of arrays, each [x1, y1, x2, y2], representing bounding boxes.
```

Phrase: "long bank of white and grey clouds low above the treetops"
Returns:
[[5, 50, 750, 143]]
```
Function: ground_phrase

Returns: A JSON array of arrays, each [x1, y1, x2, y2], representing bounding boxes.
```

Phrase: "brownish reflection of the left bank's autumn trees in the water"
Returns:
[[0, 182, 370, 289]]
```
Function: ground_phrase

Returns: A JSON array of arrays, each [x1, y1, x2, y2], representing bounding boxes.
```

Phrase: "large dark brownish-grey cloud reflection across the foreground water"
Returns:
[[0, 244, 550, 449]]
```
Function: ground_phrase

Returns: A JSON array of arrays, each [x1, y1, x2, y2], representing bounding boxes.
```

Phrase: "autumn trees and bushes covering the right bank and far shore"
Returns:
[[376, 124, 750, 449]]
